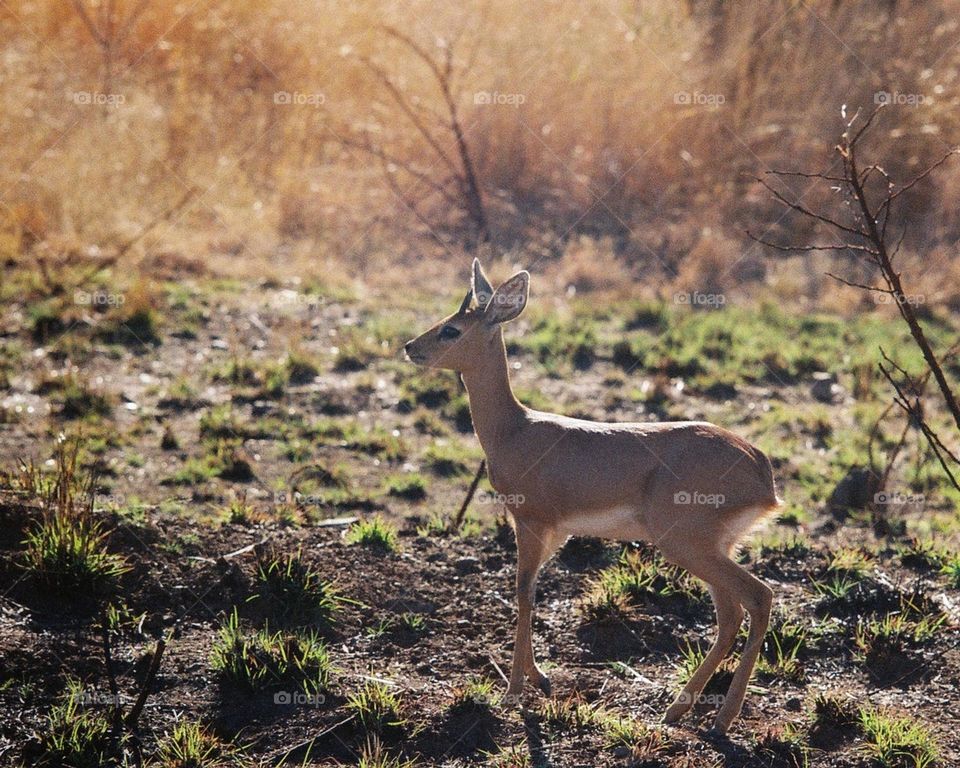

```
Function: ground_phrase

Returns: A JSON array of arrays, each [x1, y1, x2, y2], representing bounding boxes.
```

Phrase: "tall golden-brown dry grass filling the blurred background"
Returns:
[[0, 0, 960, 300]]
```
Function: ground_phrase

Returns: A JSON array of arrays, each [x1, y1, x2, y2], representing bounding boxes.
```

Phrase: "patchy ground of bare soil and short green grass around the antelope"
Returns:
[[0, 274, 960, 768]]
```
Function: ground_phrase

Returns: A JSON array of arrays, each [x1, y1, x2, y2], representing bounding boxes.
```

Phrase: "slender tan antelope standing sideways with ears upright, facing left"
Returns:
[[404, 260, 780, 733]]
